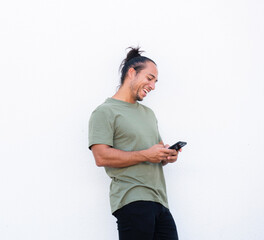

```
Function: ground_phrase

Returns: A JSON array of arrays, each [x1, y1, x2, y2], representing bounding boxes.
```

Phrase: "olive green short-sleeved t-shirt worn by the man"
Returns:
[[89, 98, 168, 213]]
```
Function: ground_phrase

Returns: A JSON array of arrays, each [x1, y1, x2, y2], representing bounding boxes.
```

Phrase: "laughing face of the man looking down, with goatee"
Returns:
[[130, 62, 158, 101]]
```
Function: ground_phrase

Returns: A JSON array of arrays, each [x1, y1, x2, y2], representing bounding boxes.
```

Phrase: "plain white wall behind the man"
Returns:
[[0, 0, 264, 240]]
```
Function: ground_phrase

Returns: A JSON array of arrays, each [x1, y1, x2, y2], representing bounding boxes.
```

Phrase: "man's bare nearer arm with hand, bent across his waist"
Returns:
[[91, 144, 177, 168]]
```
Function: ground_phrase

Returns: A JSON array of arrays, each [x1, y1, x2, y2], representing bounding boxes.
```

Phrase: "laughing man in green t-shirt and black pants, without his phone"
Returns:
[[89, 48, 182, 240]]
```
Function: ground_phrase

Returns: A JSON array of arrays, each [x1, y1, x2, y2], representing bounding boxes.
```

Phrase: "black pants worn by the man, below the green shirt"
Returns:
[[113, 201, 178, 240]]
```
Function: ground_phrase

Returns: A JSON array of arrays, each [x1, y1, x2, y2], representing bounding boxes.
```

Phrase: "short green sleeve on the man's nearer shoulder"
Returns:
[[88, 109, 114, 149]]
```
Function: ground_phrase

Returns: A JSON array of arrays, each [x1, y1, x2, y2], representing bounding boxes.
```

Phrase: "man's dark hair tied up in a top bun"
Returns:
[[119, 47, 156, 85]]
